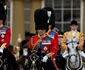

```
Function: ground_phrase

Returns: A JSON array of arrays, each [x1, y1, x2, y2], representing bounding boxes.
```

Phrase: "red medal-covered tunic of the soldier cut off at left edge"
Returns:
[[0, 26, 11, 47]]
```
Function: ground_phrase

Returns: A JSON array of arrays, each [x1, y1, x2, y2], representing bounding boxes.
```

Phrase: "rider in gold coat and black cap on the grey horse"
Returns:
[[62, 20, 85, 58]]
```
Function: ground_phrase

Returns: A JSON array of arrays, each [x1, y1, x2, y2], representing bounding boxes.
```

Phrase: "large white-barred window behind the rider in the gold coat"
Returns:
[[44, 0, 81, 31]]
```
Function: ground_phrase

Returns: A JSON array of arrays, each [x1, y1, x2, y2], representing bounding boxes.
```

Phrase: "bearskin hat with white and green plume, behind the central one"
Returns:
[[43, 7, 55, 29]]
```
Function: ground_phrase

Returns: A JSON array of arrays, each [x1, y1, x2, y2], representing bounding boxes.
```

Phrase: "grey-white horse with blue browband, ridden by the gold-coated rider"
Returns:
[[63, 38, 85, 70]]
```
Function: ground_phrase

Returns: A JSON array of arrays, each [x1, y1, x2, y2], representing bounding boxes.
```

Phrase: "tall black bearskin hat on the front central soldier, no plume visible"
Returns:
[[34, 9, 48, 31]]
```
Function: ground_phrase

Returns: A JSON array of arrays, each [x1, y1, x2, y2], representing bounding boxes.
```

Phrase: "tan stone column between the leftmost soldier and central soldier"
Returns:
[[12, 0, 25, 45]]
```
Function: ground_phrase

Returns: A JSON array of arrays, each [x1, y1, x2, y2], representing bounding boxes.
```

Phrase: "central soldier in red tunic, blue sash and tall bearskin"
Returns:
[[28, 9, 57, 70]]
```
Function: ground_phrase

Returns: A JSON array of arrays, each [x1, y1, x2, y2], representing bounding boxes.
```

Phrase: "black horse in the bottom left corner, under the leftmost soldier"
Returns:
[[0, 48, 18, 70]]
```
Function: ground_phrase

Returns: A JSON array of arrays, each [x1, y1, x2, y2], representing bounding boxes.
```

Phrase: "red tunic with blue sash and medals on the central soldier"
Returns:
[[28, 35, 58, 58]]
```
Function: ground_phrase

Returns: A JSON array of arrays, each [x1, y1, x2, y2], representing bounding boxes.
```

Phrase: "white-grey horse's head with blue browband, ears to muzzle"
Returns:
[[67, 37, 78, 65]]
